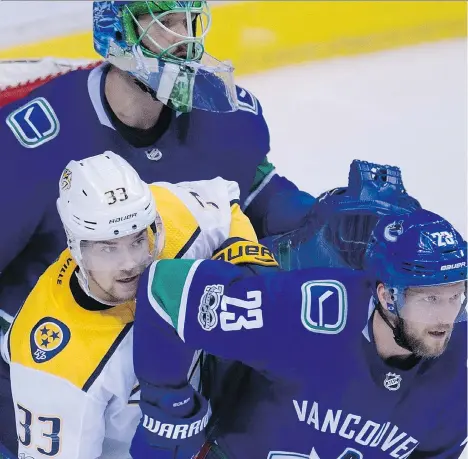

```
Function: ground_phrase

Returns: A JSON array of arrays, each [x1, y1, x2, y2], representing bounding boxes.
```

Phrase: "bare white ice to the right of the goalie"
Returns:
[[238, 40, 468, 236]]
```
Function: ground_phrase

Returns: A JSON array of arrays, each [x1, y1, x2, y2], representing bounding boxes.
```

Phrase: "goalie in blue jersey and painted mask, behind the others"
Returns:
[[0, 1, 314, 448]]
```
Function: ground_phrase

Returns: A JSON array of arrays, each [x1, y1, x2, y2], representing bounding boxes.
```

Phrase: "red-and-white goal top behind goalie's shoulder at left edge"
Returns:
[[0, 58, 101, 107]]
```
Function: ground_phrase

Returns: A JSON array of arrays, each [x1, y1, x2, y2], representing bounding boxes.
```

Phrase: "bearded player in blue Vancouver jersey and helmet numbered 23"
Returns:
[[133, 209, 467, 459]]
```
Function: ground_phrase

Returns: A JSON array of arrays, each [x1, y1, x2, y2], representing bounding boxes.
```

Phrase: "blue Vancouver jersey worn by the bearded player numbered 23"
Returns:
[[134, 260, 467, 459]]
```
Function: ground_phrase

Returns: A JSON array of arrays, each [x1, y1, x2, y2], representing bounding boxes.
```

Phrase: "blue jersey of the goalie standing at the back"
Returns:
[[0, 64, 269, 315]]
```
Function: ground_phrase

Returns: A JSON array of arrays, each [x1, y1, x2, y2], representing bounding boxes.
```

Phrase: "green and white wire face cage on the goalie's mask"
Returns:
[[122, 1, 211, 63]]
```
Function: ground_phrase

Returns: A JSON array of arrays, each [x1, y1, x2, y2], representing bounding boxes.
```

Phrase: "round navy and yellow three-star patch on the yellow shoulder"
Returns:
[[30, 317, 70, 363]]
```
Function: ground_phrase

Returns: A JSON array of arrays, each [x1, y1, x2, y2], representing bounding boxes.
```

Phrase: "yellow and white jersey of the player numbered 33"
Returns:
[[2, 178, 256, 459]]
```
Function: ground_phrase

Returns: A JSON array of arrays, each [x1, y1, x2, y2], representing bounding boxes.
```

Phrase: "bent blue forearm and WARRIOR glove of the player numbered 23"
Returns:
[[130, 270, 209, 459]]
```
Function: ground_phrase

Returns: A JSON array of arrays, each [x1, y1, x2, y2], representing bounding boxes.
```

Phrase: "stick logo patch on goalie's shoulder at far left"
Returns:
[[6, 97, 60, 148]]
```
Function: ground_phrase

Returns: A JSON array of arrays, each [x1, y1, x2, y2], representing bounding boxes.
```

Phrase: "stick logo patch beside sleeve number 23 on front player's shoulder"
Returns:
[[301, 280, 348, 334]]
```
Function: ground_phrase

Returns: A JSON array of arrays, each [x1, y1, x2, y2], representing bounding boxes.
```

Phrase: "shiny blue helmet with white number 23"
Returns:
[[364, 209, 467, 320]]
